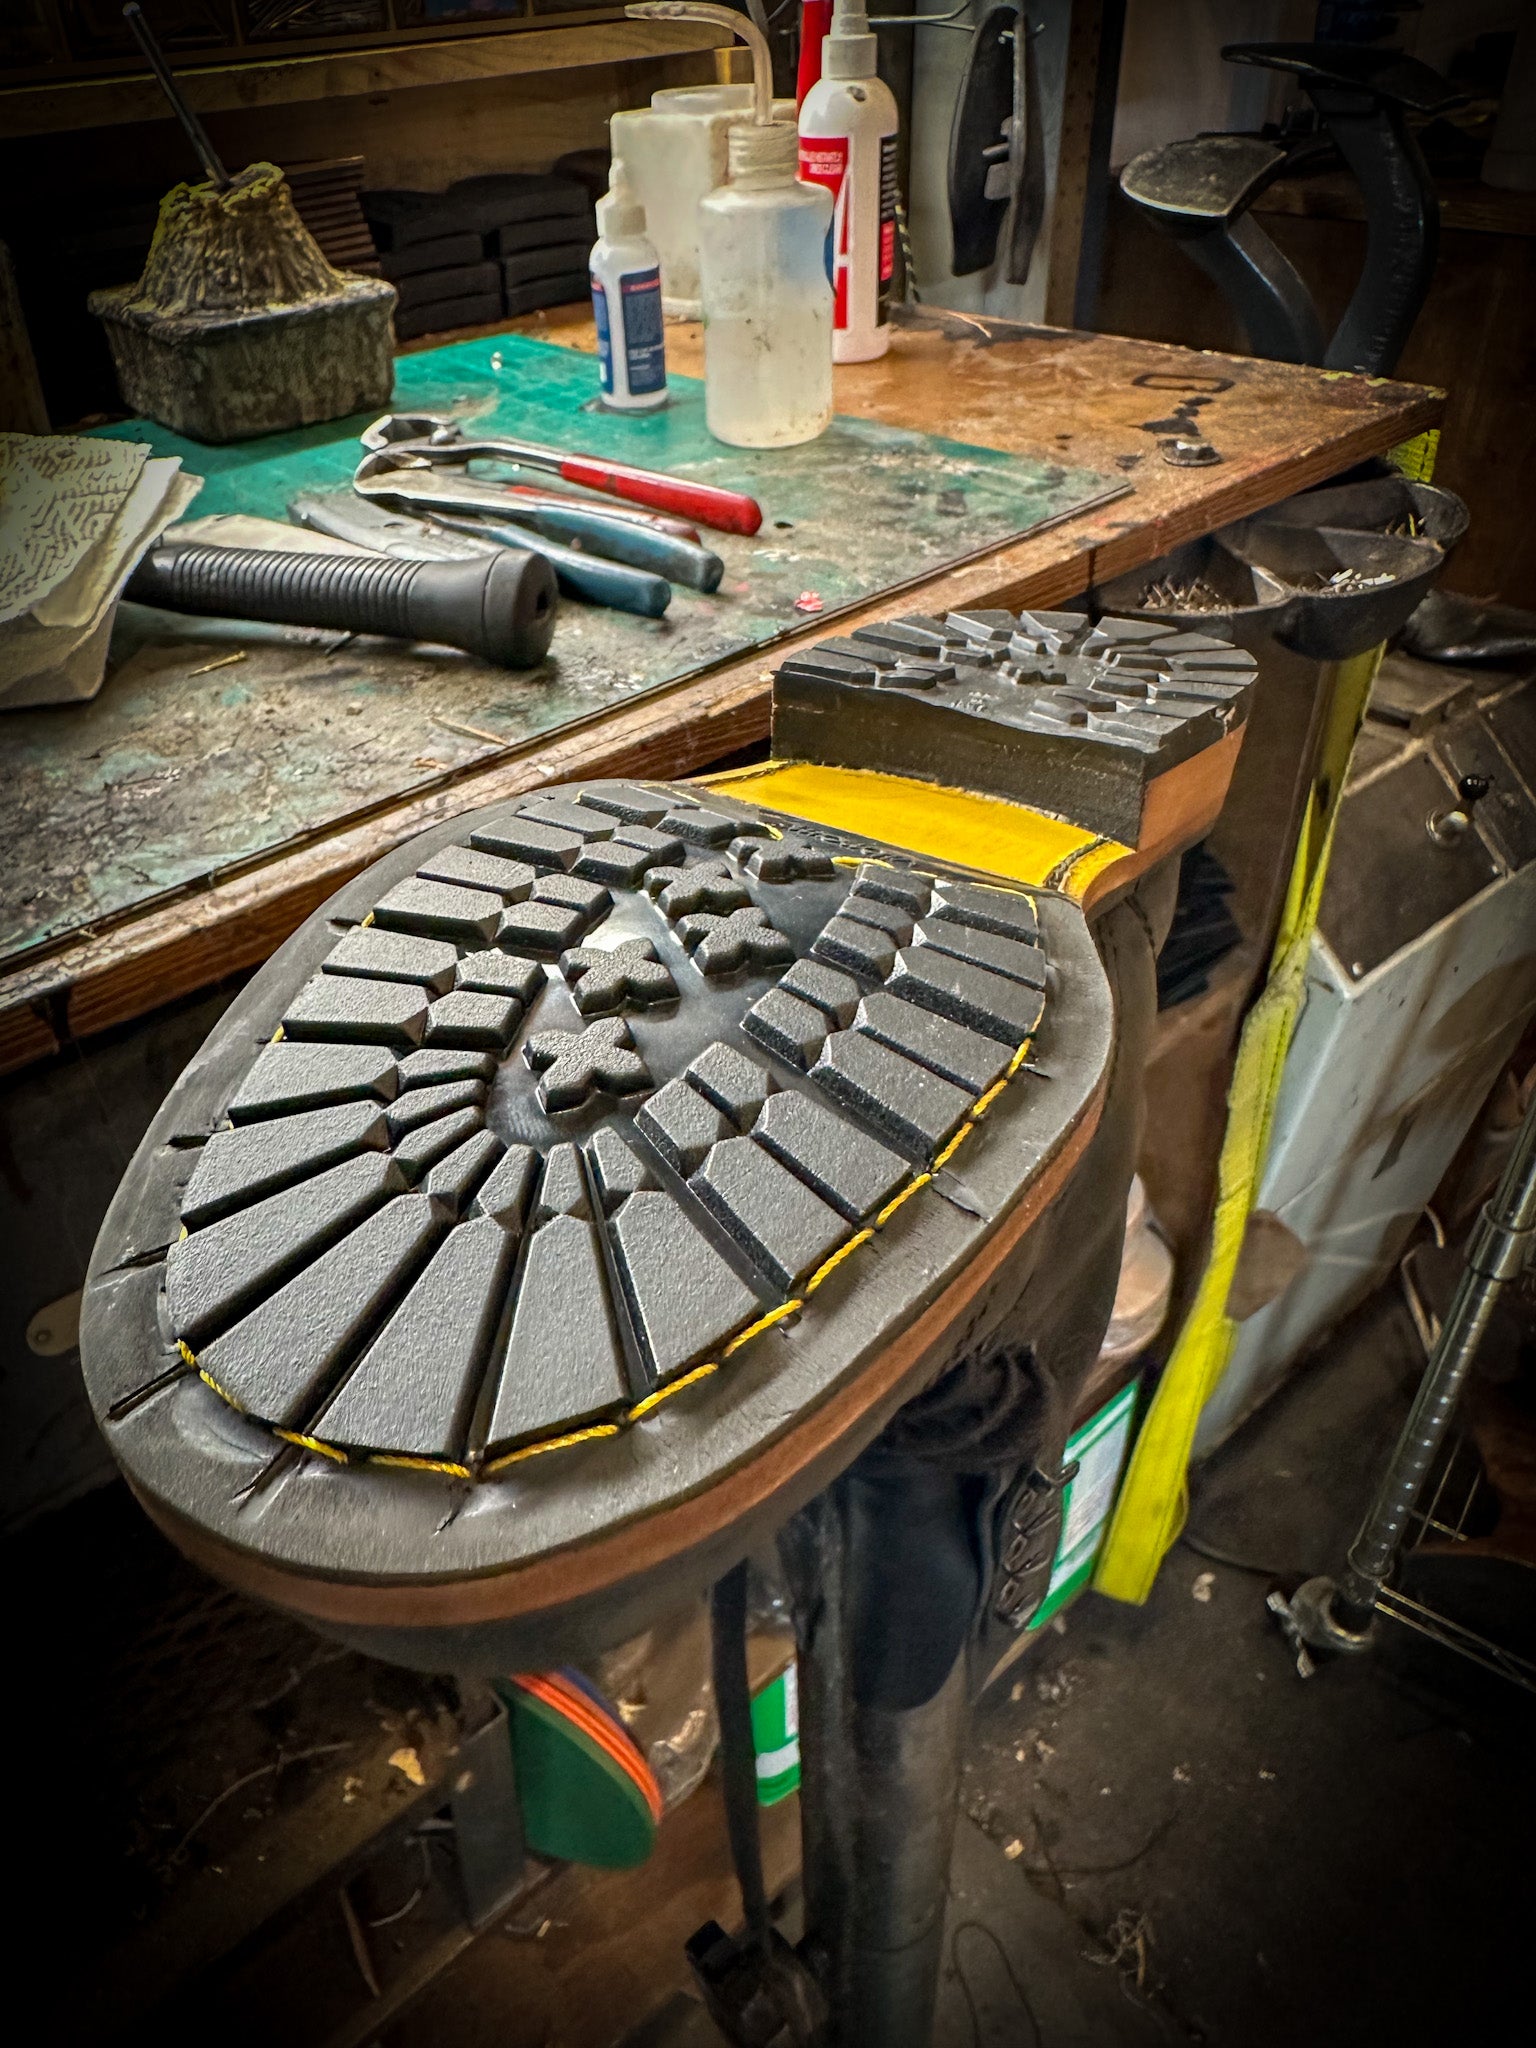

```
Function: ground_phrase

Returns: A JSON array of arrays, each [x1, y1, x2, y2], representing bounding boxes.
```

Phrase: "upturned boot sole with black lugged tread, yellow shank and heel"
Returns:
[[82, 612, 1251, 1671]]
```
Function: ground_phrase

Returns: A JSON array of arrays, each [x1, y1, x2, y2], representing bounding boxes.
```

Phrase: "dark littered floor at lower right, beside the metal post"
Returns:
[[940, 1294, 1536, 2048]]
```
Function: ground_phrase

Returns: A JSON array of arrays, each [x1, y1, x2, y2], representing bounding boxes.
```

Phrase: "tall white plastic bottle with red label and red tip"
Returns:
[[801, 0, 897, 362]]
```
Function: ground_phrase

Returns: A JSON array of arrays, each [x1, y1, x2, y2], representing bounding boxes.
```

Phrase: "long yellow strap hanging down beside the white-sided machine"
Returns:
[[1094, 647, 1384, 1606]]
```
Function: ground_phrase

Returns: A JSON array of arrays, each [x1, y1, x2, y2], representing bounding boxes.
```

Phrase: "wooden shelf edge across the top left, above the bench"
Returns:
[[0, 20, 729, 137]]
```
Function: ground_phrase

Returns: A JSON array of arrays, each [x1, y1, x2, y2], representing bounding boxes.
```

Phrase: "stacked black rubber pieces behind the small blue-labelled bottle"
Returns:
[[362, 172, 596, 342]]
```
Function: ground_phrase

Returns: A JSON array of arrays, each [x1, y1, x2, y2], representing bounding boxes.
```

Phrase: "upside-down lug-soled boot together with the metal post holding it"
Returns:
[[82, 612, 1253, 2048]]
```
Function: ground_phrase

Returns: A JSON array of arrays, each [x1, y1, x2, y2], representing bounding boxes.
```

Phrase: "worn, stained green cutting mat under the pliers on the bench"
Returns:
[[0, 334, 1126, 958]]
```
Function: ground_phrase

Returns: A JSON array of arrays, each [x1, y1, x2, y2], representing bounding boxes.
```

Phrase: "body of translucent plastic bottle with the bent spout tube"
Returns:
[[698, 121, 831, 449]]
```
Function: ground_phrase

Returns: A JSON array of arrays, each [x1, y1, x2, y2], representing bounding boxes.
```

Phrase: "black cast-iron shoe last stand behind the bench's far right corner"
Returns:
[[1120, 43, 1464, 377]]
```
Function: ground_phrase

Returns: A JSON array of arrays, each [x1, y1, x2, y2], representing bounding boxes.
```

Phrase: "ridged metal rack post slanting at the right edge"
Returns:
[[1333, 1090, 1536, 1632]]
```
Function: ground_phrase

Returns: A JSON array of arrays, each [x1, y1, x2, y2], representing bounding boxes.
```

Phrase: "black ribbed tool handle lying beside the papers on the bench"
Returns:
[[125, 543, 557, 668]]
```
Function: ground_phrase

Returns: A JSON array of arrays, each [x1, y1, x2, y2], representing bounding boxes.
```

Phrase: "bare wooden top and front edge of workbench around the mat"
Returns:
[[0, 307, 1442, 1071]]
